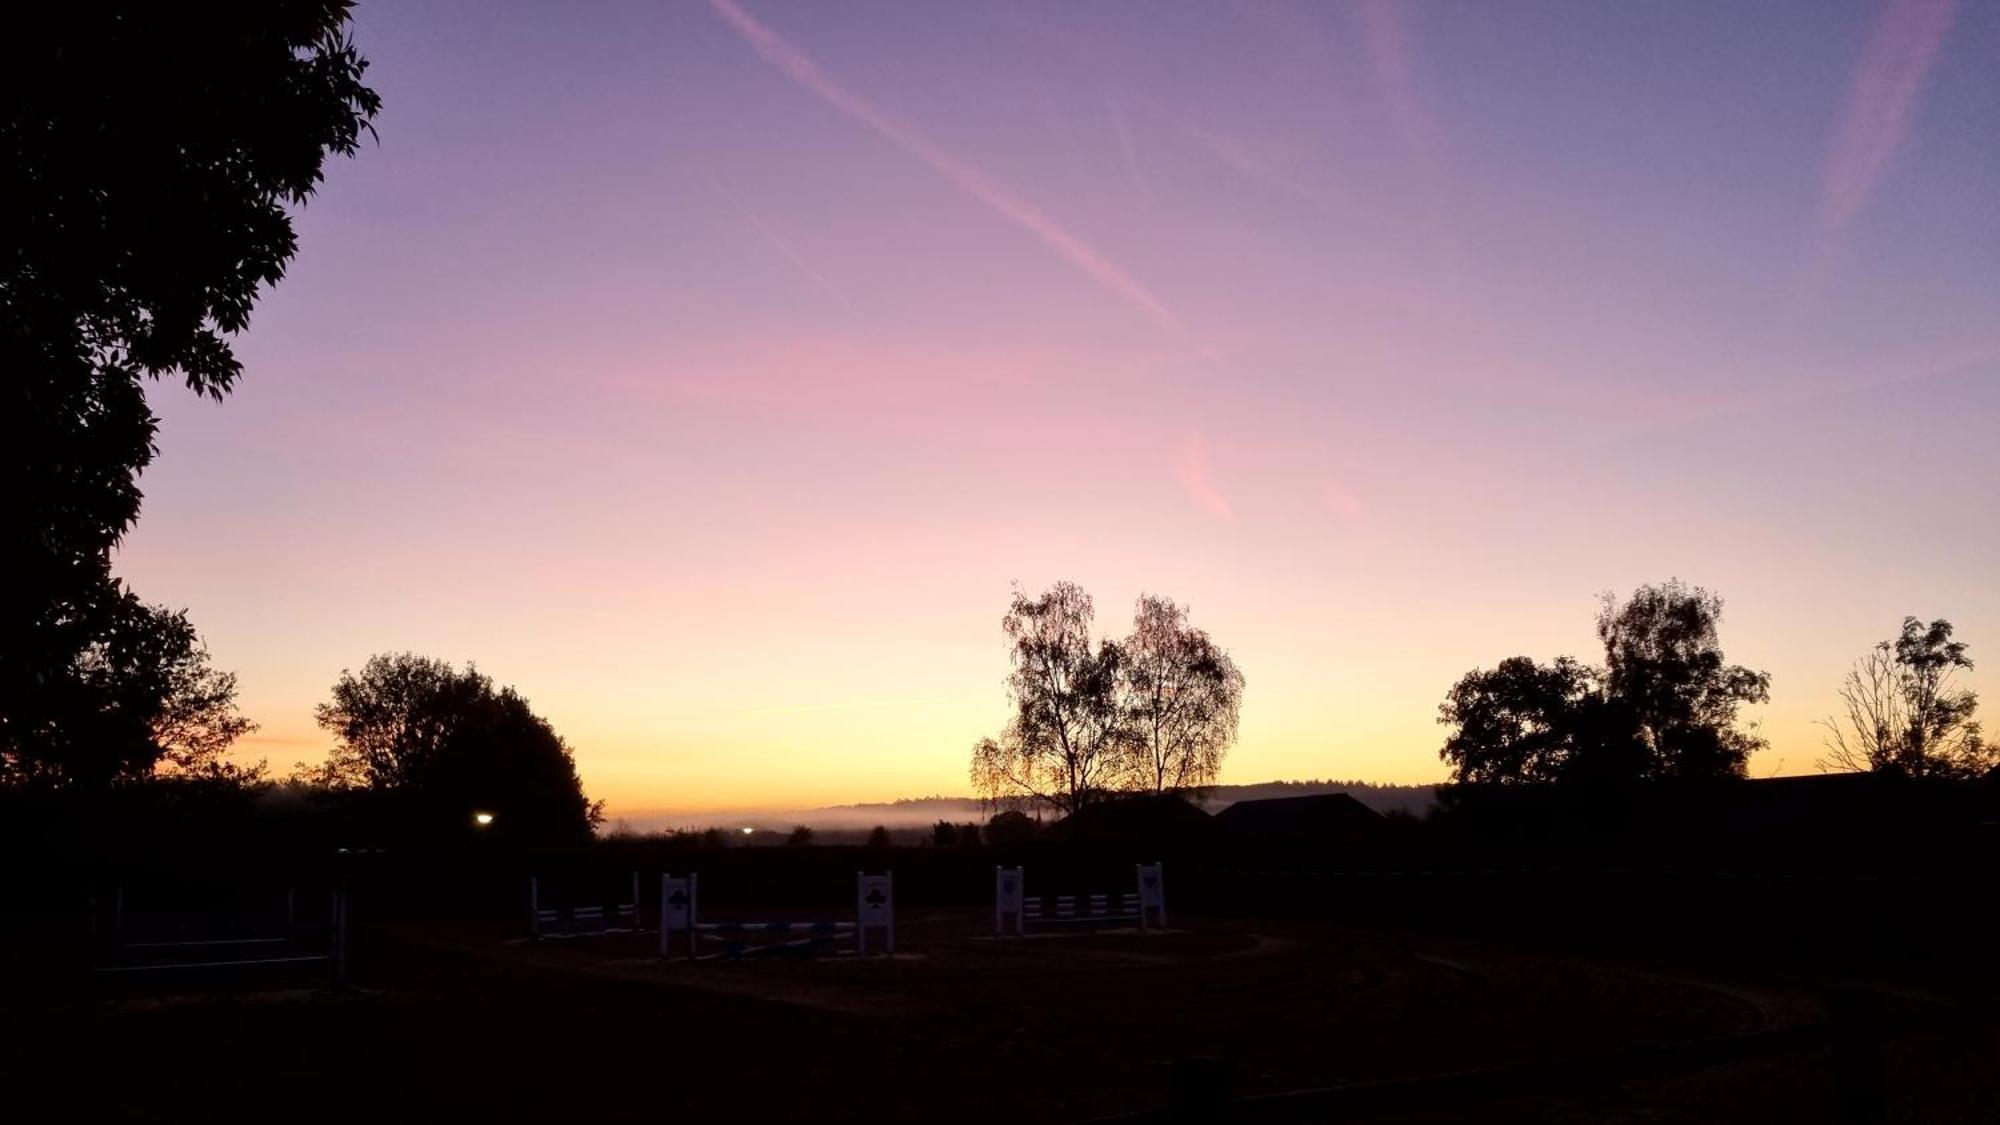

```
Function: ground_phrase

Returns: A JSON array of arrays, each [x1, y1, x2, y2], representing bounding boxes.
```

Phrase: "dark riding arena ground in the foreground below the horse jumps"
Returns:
[[0, 911, 2000, 1123]]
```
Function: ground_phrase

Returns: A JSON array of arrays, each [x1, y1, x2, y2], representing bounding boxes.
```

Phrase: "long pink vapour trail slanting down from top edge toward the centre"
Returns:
[[708, 0, 1186, 334]]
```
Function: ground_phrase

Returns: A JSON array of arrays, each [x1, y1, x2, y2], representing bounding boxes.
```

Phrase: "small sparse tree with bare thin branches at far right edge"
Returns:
[[1820, 617, 2000, 777]]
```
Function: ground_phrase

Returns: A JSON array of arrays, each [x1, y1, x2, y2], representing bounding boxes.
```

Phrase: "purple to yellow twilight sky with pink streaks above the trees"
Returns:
[[118, 0, 2000, 817]]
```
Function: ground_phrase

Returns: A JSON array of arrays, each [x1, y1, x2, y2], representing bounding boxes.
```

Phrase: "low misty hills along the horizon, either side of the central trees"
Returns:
[[608, 781, 1438, 833]]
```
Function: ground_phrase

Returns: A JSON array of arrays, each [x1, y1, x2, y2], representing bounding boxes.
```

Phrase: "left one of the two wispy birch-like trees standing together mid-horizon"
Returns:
[[972, 583, 1126, 813]]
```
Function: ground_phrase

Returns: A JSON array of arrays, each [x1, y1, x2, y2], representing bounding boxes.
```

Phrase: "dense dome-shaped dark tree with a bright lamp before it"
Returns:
[[310, 653, 604, 841]]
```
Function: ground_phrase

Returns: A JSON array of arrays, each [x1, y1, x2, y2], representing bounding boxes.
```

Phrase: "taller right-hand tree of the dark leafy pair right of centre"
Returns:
[[1598, 579, 1770, 779]]
